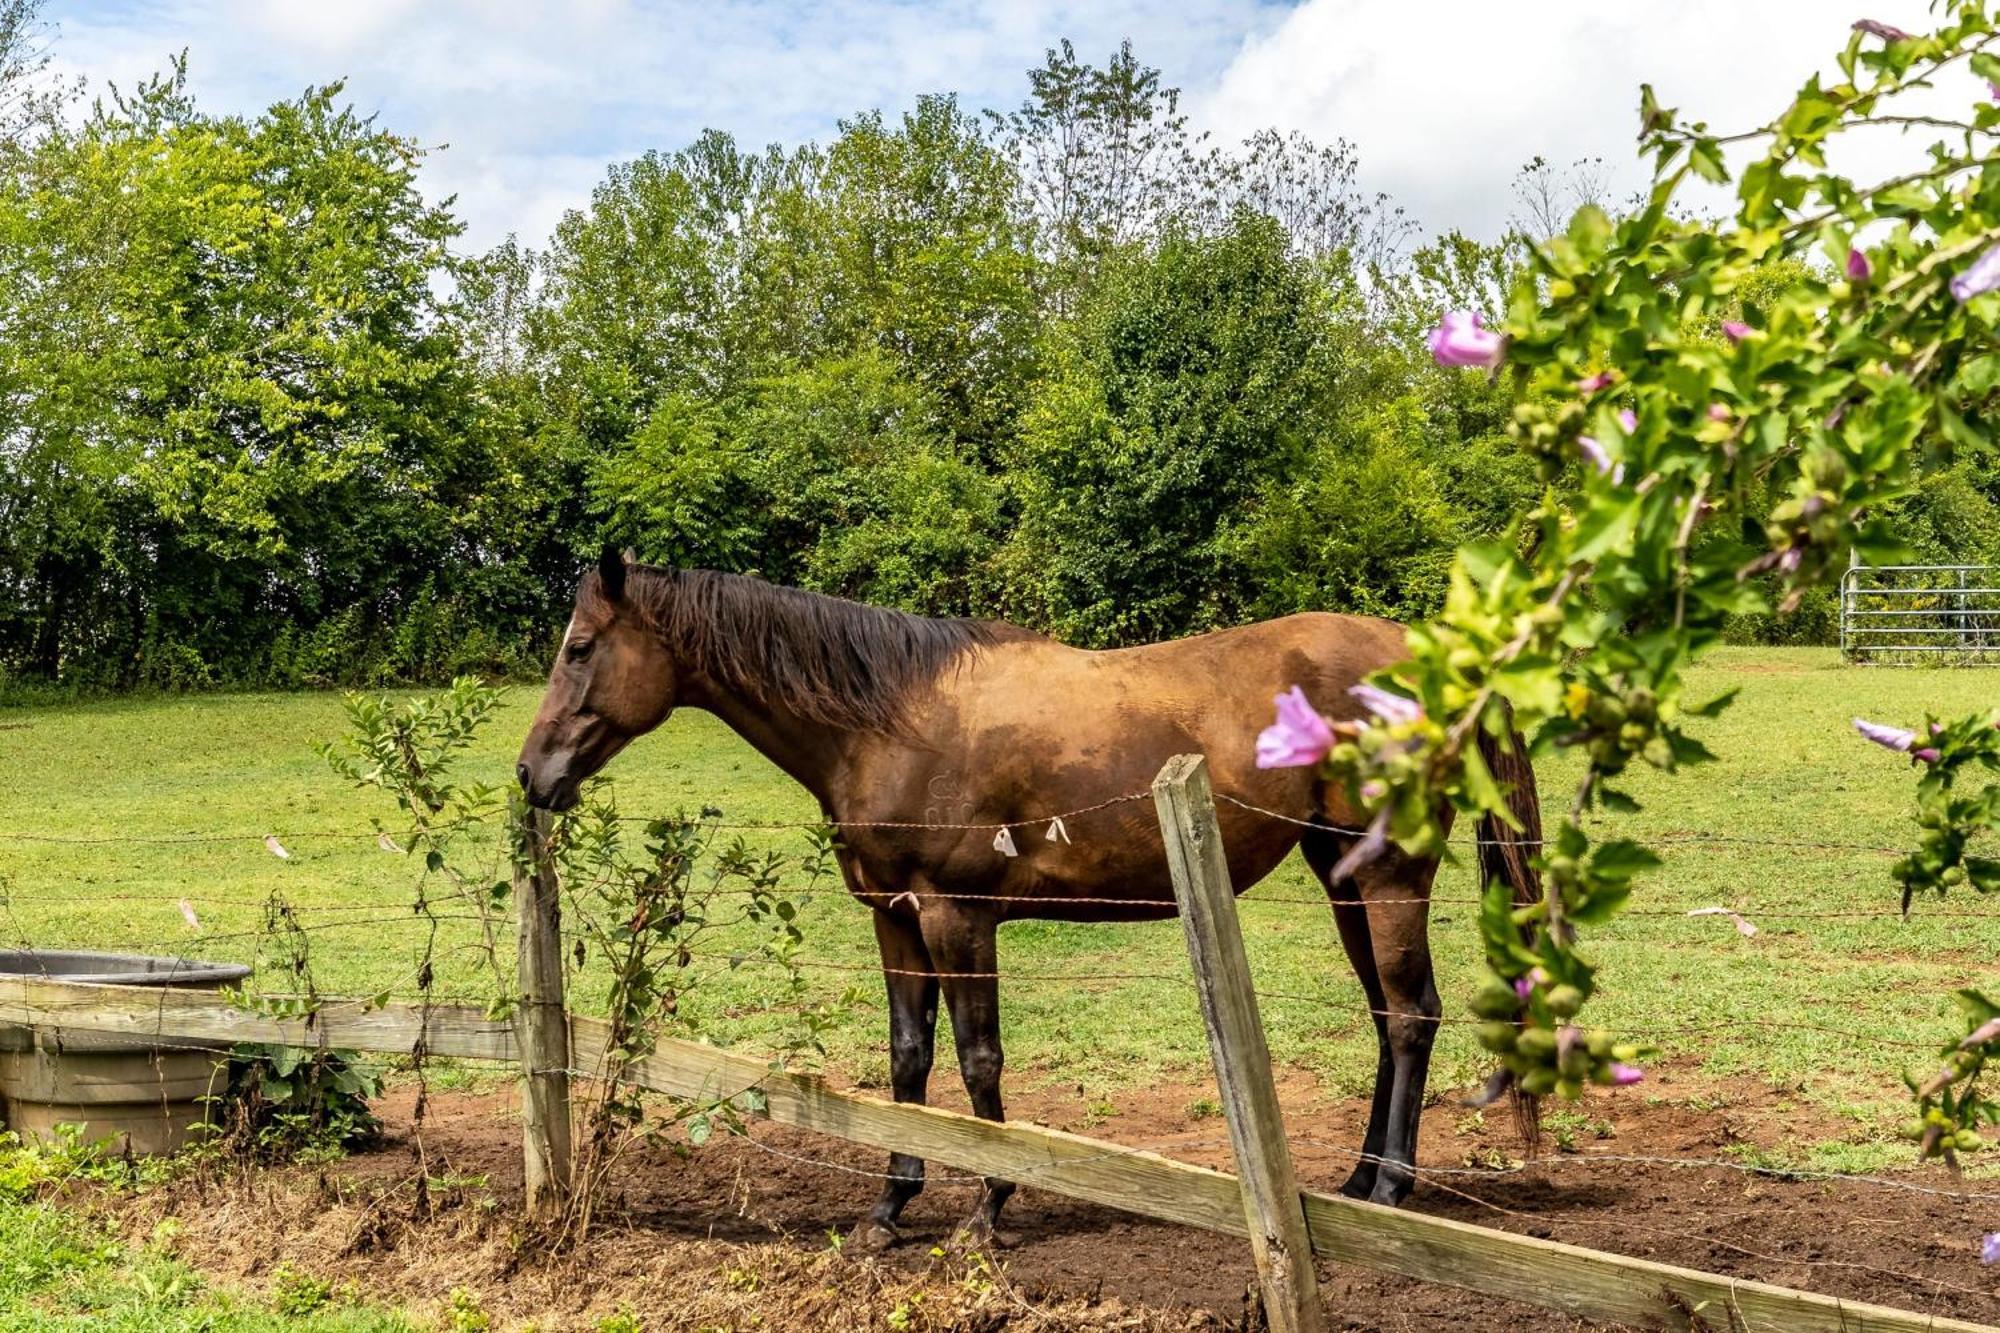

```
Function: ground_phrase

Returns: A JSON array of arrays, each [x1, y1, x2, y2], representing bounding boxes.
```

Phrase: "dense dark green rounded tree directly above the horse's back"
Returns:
[[1004, 212, 1324, 644]]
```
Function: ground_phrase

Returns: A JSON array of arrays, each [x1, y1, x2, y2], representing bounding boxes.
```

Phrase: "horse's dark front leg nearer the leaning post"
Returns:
[[922, 897, 1014, 1249]]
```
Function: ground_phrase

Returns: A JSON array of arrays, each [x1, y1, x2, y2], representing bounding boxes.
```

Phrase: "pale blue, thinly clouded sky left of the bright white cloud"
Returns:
[[50, 0, 1280, 248]]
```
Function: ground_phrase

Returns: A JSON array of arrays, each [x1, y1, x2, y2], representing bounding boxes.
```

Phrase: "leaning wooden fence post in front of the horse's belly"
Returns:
[[1152, 755, 1326, 1333]]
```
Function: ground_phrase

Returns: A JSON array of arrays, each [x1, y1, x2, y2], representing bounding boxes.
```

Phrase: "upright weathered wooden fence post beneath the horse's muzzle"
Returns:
[[514, 809, 572, 1217]]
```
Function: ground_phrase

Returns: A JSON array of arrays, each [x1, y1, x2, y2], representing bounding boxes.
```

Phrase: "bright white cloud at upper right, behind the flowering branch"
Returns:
[[1194, 0, 1960, 236]]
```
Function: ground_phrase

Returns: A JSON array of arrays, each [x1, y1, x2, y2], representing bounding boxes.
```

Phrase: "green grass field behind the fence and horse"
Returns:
[[0, 648, 2000, 1143]]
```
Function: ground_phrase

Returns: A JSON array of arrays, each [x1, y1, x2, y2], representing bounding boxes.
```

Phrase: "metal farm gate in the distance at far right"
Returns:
[[1840, 564, 2000, 667]]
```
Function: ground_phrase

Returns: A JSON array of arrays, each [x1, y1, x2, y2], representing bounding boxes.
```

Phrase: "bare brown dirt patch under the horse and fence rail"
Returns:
[[101, 1071, 2000, 1333]]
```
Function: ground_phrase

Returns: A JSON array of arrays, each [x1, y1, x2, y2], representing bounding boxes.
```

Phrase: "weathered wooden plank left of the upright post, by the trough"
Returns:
[[0, 964, 518, 1063]]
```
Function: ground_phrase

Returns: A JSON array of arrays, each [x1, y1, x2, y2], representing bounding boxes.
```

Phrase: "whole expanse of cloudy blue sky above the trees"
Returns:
[[48, 0, 1968, 248]]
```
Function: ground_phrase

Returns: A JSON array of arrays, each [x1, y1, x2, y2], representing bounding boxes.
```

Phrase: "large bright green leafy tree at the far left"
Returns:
[[0, 68, 484, 683]]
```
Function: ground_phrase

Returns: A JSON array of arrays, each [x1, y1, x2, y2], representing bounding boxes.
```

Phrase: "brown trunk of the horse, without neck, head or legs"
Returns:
[[848, 614, 1404, 915]]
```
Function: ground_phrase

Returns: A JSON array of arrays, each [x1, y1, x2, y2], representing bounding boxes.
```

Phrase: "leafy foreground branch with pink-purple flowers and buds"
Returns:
[[1260, 0, 2000, 1128]]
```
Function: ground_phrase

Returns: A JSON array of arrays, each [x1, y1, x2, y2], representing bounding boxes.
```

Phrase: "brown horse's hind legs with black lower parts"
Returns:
[[1304, 833, 1442, 1203]]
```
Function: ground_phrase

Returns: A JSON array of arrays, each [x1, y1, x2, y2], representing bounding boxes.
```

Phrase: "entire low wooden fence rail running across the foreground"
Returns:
[[0, 964, 1994, 1333]]
